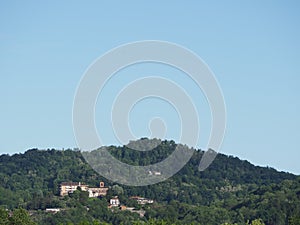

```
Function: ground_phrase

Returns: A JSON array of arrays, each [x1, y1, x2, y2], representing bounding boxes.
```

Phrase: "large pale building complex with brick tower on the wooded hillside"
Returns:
[[60, 182, 108, 198]]
